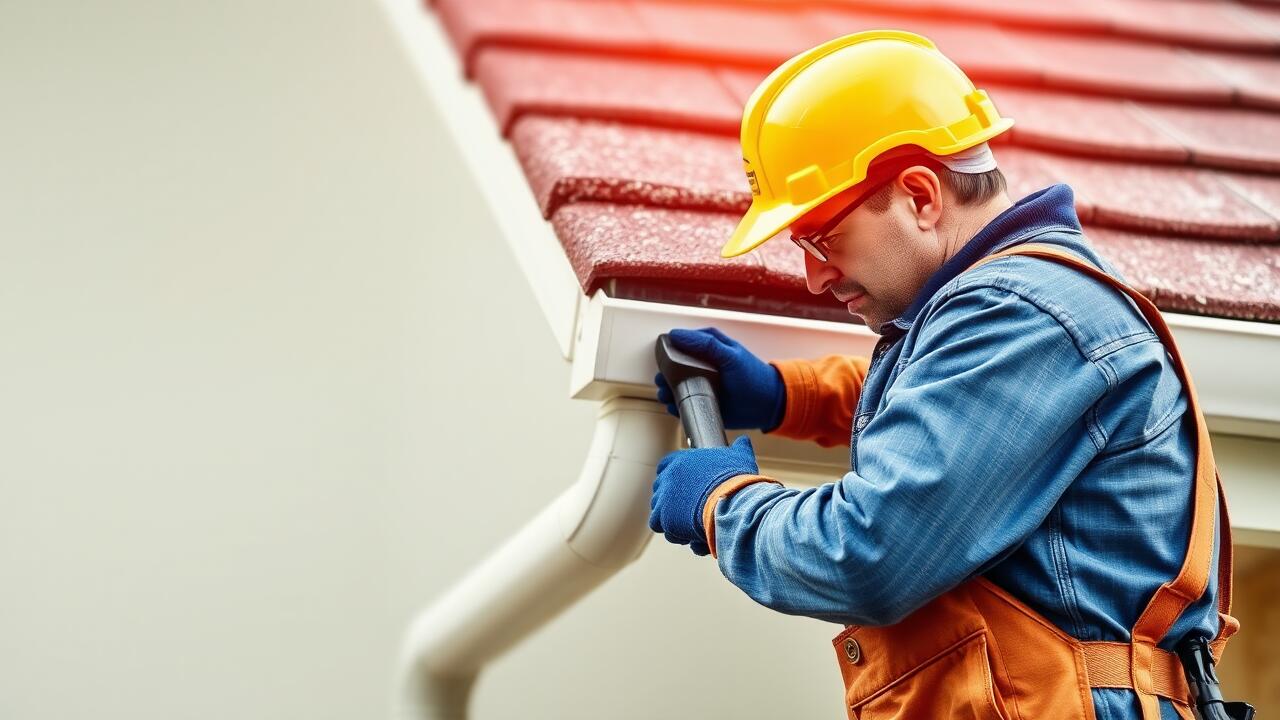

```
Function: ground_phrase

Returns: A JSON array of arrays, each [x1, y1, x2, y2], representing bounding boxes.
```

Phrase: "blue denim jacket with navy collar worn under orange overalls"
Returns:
[[714, 184, 1217, 720]]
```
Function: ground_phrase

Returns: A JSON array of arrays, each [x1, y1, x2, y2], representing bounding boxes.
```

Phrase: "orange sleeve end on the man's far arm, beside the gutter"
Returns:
[[772, 355, 869, 447]]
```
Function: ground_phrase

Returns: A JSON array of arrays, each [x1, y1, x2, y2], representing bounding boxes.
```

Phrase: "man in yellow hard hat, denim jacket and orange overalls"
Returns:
[[650, 31, 1238, 720]]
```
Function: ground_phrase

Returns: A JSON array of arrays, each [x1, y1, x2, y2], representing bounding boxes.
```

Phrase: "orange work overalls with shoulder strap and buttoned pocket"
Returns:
[[703, 243, 1239, 720]]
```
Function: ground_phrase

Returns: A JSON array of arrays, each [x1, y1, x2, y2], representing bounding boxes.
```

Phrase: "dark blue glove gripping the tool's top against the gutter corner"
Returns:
[[653, 328, 787, 430]]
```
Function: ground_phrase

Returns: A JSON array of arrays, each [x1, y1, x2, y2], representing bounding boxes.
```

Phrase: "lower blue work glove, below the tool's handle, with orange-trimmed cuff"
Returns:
[[649, 436, 760, 555]]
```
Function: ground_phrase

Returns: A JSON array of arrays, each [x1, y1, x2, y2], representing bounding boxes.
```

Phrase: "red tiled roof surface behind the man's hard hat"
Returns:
[[434, 0, 1280, 322]]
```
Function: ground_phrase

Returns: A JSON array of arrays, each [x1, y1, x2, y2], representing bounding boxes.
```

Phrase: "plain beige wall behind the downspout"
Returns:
[[0, 0, 841, 720]]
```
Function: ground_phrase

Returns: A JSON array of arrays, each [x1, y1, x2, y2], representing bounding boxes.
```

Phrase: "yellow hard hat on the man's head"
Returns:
[[721, 29, 1014, 258]]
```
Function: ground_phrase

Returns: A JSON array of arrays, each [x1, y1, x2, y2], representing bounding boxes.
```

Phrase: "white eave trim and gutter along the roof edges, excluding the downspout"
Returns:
[[381, 0, 1280, 547]]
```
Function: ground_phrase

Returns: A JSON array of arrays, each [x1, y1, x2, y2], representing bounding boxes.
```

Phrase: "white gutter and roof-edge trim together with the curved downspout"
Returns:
[[381, 0, 1280, 720]]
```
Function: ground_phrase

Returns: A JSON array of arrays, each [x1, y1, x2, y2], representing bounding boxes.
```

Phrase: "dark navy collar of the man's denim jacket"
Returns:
[[881, 184, 1082, 336]]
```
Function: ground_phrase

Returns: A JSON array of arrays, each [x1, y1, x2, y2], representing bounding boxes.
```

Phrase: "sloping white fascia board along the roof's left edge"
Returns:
[[381, 0, 582, 357]]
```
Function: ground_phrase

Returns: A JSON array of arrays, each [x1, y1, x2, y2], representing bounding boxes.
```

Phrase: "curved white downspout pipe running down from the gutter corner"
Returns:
[[394, 397, 676, 720]]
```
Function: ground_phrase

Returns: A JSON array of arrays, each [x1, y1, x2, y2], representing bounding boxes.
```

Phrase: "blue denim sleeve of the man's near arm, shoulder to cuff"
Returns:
[[713, 288, 1108, 625]]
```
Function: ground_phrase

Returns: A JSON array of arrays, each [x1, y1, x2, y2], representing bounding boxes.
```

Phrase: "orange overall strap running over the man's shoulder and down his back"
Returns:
[[974, 243, 1231, 720]]
